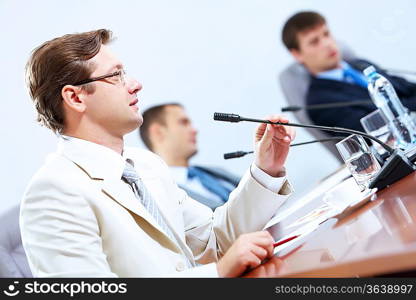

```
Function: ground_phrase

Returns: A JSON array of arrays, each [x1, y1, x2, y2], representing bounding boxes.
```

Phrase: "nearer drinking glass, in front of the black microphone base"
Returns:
[[336, 134, 380, 191]]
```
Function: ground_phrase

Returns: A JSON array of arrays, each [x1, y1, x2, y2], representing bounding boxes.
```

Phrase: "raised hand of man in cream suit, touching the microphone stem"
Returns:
[[254, 115, 295, 177]]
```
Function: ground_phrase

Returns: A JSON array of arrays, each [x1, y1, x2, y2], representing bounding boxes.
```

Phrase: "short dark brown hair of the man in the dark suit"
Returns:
[[282, 11, 326, 50]]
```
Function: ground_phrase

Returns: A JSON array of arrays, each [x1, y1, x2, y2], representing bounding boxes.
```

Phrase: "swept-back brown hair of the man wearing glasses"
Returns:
[[26, 29, 112, 133]]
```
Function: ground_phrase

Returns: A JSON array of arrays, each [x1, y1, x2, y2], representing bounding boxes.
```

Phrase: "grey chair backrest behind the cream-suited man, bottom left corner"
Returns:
[[0, 205, 32, 278]]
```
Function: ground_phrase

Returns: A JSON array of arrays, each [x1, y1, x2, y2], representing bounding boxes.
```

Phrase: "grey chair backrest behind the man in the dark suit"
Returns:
[[279, 42, 356, 162]]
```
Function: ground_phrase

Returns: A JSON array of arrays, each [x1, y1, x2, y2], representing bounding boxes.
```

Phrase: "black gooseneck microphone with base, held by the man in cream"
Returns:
[[214, 112, 415, 190]]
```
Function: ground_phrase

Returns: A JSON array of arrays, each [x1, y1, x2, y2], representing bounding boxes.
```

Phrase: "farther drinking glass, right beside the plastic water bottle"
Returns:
[[360, 109, 397, 157]]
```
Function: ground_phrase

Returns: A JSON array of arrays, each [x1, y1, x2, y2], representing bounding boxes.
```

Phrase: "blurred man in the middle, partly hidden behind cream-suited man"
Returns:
[[140, 103, 240, 209]]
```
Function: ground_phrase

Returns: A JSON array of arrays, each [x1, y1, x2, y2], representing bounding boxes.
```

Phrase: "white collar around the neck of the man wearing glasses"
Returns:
[[58, 136, 126, 179]]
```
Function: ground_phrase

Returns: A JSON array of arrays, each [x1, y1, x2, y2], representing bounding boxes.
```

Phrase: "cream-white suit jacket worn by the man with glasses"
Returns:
[[20, 138, 291, 277]]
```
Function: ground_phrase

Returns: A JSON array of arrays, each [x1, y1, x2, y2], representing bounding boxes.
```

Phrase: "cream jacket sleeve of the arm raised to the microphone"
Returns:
[[183, 170, 292, 264]]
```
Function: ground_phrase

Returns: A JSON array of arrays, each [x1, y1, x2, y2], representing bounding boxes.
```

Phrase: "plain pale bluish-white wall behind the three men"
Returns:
[[0, 0, 416, 213]]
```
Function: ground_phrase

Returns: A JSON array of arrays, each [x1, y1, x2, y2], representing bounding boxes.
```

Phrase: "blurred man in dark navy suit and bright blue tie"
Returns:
[[282, 12, 416, 135]]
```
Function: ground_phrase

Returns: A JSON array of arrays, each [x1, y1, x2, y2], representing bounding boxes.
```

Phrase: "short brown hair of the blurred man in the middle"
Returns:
[[139, 102, 183, 151]]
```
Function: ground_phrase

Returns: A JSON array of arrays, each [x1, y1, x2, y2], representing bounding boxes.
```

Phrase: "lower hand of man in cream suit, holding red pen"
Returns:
[[217, 231, 274, 277]]
